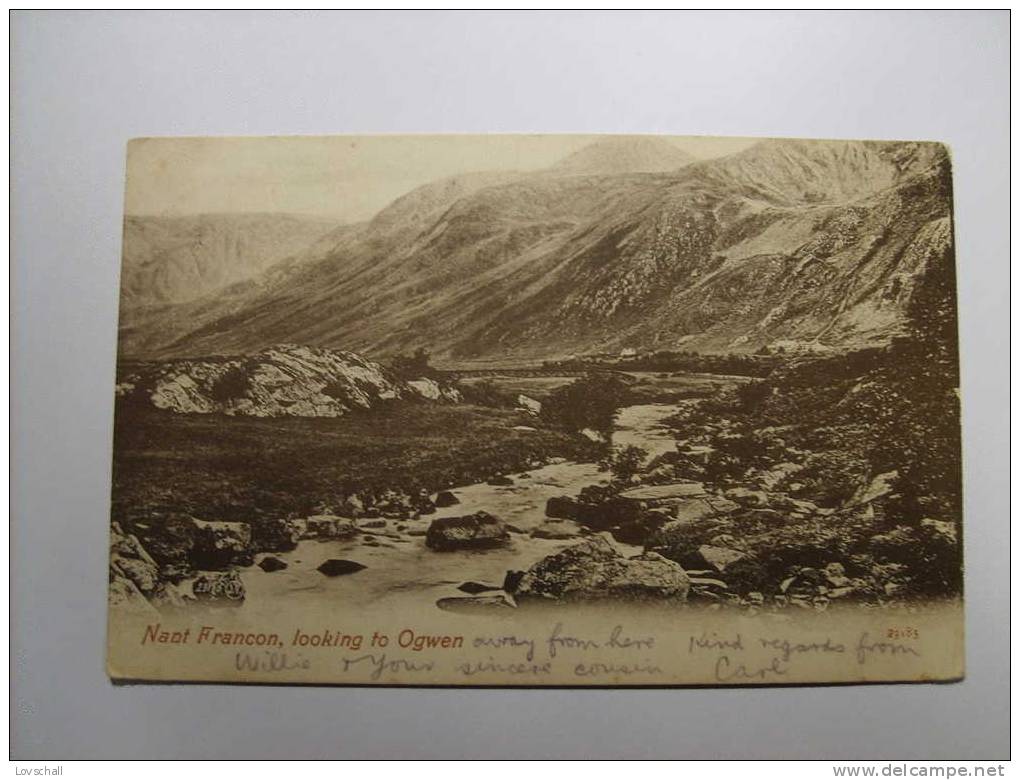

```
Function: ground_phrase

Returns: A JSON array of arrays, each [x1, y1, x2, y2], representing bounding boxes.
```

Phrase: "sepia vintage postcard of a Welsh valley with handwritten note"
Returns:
[[108, 135, 964, 686]]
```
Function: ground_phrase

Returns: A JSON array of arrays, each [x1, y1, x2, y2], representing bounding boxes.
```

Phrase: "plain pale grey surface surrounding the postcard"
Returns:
[[11, 12, 1009, 760]]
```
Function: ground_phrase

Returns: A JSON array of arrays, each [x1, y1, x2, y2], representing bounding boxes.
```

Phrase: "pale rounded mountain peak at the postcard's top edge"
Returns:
[[550, 136, 696, 173]]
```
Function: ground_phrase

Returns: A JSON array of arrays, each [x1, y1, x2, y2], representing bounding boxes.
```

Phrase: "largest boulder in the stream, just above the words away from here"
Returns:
[[514, 536, 691, 603]]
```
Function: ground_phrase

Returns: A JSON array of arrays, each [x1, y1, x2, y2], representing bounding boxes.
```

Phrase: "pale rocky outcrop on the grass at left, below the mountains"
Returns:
[[117, 345, 461, 417]]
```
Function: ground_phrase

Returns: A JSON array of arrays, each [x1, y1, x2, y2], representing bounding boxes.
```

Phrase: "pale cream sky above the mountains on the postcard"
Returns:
[[124, 135, 755, 222]]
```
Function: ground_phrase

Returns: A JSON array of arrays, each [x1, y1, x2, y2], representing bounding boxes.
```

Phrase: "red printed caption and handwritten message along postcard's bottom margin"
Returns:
[[133, 622, 921, 684]]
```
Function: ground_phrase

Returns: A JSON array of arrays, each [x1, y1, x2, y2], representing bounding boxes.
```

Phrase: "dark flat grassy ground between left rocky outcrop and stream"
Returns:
[[112, 391, 597, 524]]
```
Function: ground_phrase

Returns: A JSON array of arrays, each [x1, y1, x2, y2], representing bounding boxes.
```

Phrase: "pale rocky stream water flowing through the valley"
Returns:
[[240, 404, 678, 616]]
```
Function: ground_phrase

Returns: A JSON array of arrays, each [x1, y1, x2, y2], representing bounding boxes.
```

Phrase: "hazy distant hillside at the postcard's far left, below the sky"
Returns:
[[121, 214, 337, 307]]
